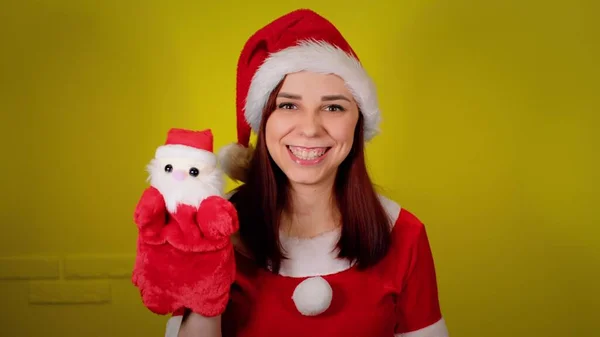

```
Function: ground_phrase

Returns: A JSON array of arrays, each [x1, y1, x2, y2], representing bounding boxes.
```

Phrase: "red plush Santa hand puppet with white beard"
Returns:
[[132, 129, 238, 316]]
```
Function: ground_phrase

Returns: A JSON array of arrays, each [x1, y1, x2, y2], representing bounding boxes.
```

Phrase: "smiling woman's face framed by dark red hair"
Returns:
[[265, 72, 359, 185]]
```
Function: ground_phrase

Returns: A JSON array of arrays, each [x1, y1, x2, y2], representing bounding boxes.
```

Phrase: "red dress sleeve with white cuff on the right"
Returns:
[[394, 210, 446, 337]]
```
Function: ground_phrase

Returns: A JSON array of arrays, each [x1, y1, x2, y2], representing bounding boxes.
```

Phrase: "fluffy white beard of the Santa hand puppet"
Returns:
[[150, 169, 225, 213]]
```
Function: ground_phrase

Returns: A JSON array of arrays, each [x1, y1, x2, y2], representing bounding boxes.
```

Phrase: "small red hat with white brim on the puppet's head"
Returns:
[[155, 128, 217, 166]]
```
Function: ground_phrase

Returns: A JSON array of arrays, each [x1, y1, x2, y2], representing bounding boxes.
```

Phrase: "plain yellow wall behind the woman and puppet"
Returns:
[[0, 0, 600, 337]]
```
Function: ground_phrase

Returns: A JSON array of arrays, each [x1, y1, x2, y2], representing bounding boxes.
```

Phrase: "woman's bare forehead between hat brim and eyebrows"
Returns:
[[280, 71, 352, 98]]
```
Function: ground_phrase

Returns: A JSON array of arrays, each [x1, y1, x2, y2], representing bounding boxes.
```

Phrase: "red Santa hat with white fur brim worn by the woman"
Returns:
[[219, 9, 380, 181]]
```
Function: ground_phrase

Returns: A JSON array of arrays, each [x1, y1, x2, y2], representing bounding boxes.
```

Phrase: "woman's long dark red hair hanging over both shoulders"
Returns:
[[230, 81, 390, 273]]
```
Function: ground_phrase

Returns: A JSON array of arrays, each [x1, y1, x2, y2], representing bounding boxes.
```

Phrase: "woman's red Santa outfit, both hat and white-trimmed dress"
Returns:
[[166, 10, 448, 337]]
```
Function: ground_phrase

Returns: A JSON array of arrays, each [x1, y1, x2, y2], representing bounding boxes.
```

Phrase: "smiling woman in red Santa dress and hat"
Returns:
[[167, 10, 447, 337]]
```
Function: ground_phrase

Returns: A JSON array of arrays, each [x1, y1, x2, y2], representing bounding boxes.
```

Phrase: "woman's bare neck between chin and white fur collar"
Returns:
[[281, 183, 340, 238]]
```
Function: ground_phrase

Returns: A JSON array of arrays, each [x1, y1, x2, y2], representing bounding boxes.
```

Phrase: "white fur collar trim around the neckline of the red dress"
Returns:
[[279, 195, 401, 277]]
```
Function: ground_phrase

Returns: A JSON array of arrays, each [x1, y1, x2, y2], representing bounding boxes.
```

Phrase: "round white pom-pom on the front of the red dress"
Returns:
[[292, 276, 333, 316]]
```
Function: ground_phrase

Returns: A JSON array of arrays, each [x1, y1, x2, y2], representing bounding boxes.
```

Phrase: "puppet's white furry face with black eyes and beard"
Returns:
[[148, 158, 224, 211]]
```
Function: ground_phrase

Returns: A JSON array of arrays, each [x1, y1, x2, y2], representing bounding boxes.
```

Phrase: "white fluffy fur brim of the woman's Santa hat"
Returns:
[[244, 40, 381, 140]]
